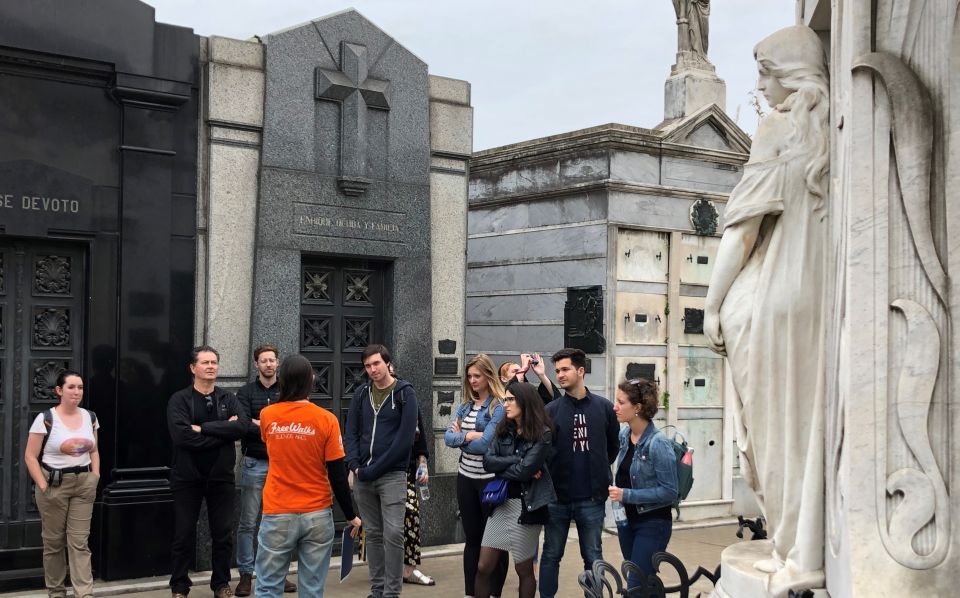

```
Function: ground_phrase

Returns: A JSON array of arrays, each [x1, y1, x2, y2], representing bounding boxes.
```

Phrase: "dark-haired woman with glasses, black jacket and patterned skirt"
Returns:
[[476, 381, 557, 598]]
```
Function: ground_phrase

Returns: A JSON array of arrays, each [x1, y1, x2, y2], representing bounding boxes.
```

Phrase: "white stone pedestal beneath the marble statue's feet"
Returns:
[[710, 540, 829, 598]]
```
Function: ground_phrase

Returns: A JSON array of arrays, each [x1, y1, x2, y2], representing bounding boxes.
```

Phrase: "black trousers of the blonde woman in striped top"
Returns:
[[457, 473, 510, 596]]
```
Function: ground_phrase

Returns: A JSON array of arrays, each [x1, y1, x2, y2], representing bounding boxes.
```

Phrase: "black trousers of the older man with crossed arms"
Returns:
[[170, 481, 236, 594]]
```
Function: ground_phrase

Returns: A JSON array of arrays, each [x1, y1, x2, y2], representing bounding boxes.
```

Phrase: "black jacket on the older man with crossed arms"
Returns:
[[167, 385, 250, 488]]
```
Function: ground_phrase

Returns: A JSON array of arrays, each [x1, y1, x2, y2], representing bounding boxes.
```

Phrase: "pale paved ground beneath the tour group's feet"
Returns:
[[0, 525, 740, 598]]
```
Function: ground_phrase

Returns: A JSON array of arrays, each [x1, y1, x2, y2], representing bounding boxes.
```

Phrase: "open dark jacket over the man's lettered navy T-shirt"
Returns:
[[540, 384, 620, 503]]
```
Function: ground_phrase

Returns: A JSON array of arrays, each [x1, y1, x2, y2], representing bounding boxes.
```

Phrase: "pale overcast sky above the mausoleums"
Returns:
[[146, 0, 796, 150]]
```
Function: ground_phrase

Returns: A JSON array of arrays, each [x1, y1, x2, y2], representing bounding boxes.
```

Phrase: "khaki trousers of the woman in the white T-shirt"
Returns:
[[33, 470, 100, 598]]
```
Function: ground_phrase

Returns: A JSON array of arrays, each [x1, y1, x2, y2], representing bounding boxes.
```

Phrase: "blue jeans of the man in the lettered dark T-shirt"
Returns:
[[540, 500, 604, 598]]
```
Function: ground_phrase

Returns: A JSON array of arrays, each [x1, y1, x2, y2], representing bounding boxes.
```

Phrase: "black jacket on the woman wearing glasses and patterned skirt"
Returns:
[[483, 428, 557, 523]]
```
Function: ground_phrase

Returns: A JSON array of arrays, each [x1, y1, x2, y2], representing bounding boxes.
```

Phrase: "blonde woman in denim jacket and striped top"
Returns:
[[443, 353, 509, 597]]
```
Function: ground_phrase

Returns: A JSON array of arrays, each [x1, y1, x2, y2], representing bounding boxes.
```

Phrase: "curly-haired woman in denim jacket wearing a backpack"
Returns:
[[610, 379, 678, 588]]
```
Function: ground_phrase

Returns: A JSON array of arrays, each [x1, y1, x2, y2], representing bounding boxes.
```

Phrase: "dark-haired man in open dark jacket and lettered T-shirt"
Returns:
[[534, 349, 620, 598]]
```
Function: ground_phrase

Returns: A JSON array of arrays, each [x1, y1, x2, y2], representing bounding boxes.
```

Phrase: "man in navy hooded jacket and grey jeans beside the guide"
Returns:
[[343, 345, 418, 598]]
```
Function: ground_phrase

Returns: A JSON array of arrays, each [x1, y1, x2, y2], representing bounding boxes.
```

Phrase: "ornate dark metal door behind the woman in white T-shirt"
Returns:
[[0, 240, 86, 552]]
